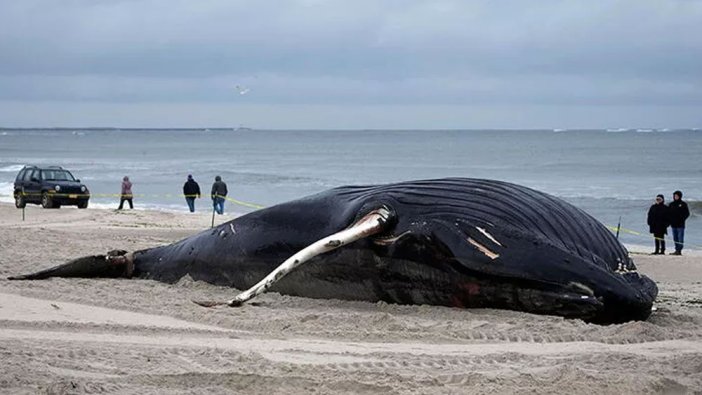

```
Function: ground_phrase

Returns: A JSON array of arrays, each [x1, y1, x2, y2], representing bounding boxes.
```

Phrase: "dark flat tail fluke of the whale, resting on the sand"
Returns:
[[7, 250, 134, 280]]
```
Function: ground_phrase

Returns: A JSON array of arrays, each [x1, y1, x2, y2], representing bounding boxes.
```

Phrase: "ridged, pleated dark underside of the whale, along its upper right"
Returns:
[[328, 178, 633, 270]]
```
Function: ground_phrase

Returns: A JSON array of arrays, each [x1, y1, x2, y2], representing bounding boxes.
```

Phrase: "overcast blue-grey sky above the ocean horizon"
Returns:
[[0, 0, 702, 129]]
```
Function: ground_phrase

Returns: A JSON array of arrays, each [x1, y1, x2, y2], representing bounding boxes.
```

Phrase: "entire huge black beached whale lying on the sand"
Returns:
[[11, 178, 658, 323]]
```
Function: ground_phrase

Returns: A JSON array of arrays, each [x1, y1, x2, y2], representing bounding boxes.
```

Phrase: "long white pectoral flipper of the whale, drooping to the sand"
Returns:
[[193, 206, 391, 307]]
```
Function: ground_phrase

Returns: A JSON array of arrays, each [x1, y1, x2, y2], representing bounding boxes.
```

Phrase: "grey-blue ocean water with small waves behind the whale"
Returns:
[[0, 129, 702, 249]]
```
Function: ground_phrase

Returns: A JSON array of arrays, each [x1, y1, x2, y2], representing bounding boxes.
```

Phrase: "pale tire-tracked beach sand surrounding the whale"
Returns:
[[0, 204, 702, 395]]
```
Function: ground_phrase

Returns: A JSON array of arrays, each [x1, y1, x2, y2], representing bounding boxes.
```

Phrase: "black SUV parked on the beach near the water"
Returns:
[[14, 166, 90, 208]]
